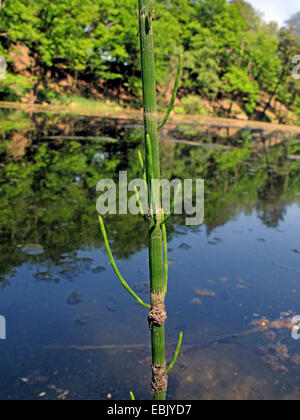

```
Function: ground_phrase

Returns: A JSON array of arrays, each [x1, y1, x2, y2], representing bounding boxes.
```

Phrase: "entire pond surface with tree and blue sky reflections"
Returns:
[[0, 112, 300, 399]]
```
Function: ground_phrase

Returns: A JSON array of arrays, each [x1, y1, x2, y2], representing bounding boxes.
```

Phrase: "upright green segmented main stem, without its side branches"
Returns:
[[139, 0, 166, 400]]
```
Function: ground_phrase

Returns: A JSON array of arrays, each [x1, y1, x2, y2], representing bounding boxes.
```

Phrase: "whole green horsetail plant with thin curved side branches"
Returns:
[[99, 0, 182, 400]]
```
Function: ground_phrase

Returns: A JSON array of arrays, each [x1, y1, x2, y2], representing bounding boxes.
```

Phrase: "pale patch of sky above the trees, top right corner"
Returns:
[[247, 0, 300, 25]]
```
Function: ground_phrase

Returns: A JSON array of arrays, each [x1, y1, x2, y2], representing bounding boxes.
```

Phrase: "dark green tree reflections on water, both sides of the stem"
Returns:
[[0, 110, 300, 284]]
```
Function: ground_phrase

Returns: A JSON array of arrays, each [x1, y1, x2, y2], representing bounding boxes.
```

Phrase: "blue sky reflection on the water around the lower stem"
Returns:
[[0, 112, 300, 399]]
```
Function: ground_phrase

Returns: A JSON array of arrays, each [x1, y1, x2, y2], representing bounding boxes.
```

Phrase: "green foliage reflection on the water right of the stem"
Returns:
[[162, 137, 300, 231]]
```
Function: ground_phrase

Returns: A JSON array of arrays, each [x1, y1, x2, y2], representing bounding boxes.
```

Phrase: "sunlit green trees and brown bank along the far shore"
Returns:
[[0, 0, 300, 123]]
